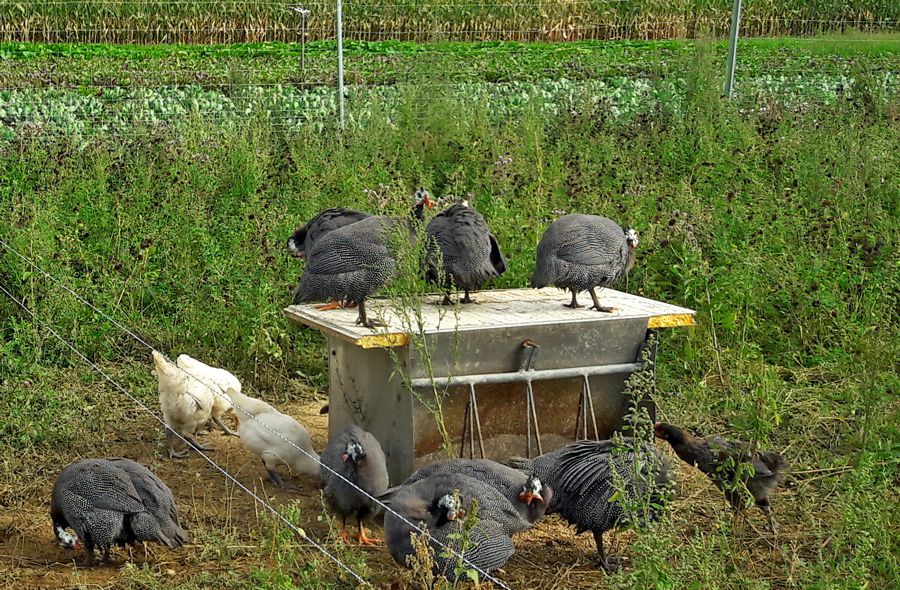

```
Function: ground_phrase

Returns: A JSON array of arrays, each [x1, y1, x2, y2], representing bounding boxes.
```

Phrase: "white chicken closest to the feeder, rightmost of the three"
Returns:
[[227, 388, 319, 490]]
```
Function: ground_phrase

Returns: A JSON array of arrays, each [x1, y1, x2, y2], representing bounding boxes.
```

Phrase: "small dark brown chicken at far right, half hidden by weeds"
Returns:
[[654, 423, 788, 533]]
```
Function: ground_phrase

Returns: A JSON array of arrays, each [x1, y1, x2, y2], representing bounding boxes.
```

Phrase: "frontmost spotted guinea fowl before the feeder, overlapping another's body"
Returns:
[[384, 473, 531, 576]]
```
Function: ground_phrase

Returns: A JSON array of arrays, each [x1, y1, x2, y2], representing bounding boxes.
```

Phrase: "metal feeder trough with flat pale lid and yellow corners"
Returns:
[[285, 289, 694, 482]]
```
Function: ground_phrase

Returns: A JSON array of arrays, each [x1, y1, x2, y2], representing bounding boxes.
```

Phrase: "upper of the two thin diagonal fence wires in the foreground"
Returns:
[[0, 239, 511, 590]]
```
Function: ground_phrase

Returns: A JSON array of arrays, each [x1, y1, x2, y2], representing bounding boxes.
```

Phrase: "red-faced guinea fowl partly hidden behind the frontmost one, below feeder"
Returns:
[[383, 459, 553, 523]]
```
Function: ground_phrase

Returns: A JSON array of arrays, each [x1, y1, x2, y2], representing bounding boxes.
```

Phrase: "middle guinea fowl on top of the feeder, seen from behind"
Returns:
[[425, 201, 506, 305]]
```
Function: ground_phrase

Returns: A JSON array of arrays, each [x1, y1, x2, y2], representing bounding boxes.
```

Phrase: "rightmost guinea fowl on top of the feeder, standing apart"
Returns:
[[531, 213, 638, 312]]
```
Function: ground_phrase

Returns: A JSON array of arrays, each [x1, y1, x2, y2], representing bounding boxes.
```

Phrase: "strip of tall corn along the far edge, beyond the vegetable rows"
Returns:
[[0, 0, 900, 44]]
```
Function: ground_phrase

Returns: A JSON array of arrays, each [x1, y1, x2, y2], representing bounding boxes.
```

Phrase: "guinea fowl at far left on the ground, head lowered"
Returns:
[[50, 459, 187, 564]]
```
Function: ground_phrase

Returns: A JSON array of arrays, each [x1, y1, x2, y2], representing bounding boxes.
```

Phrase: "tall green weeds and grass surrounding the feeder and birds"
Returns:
[[0, 47, 900, 589]]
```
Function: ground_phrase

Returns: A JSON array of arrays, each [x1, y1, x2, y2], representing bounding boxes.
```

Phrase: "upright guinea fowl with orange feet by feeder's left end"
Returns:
[[319, 425, 388, 545]]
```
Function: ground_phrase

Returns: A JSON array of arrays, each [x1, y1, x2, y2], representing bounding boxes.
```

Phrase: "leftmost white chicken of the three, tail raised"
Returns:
[[153, 350, 215, 459]]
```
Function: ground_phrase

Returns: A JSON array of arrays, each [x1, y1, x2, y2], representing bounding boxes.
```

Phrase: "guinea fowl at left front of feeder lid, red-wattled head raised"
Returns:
[[293, 189, 434, 328]]
